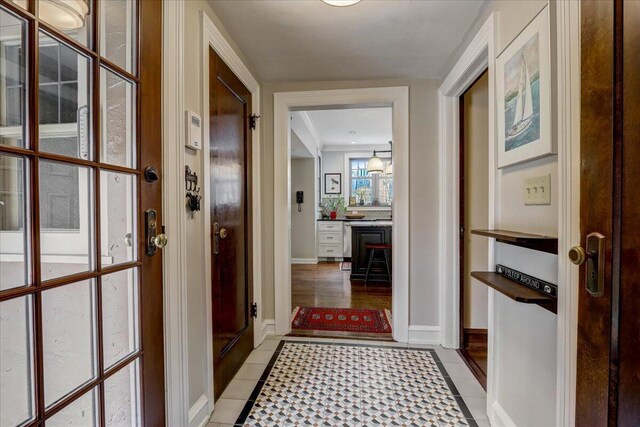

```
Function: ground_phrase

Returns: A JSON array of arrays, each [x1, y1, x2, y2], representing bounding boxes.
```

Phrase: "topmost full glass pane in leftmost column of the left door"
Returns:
[[0, 9, 27, 147]]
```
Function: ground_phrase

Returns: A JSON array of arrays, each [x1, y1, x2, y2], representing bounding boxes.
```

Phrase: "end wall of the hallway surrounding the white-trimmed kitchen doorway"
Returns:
[[261, 79, 440, 327]]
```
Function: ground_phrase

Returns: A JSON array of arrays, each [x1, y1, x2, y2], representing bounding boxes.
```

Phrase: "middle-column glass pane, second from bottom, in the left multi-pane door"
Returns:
[[42, 280, 96, 407]]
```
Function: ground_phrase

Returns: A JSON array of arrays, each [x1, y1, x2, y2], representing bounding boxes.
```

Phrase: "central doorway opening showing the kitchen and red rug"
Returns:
[[289, 104, 393, 340]]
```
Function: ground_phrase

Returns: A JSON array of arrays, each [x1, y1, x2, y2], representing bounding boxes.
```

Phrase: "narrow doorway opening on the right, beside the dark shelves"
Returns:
[[459, 71, 489, 389]]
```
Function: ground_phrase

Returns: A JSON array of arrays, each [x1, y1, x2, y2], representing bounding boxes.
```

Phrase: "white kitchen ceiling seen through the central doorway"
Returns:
[[303, 107, 393, 148]]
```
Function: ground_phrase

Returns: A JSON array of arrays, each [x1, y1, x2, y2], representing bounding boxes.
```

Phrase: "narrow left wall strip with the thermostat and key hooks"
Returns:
[[183, 0, 256, 414]]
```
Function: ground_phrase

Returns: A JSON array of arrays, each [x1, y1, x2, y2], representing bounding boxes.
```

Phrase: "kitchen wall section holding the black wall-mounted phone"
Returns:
[[291, 158, 317, 260]]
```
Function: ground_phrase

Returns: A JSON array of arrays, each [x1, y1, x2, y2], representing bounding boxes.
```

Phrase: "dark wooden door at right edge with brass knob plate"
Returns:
[[576, 0, 640, 426]]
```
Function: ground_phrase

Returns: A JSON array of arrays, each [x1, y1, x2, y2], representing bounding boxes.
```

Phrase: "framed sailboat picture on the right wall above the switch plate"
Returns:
[[496, 6, 555, 168]]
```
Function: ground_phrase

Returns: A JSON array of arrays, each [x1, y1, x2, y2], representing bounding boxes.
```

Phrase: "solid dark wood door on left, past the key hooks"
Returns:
[[209, 49, 253, 399]]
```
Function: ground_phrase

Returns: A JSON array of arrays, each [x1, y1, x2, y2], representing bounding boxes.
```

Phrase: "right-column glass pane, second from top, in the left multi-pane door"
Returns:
[[100, 68, 136, 168]]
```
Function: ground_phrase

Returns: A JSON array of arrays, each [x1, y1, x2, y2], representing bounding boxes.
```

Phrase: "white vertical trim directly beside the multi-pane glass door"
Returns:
[[162, 2, 189, 426]]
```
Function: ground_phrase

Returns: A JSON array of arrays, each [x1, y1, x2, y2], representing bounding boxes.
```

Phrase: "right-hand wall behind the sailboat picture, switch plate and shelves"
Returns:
[[452, 1, 563, 427]]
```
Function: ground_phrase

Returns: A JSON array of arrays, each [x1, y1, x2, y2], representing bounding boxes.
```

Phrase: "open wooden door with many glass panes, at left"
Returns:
[[0, 0, 165, 426]]
